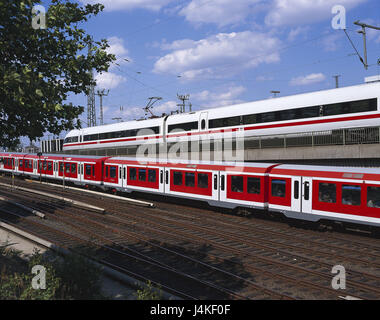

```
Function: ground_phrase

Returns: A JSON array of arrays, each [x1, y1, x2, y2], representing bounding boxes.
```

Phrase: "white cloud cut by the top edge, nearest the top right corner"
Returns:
[[265, 0, 367, 26]]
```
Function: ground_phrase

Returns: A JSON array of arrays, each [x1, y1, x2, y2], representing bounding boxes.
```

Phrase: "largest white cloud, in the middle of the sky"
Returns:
[[154, 31, 281, 80]]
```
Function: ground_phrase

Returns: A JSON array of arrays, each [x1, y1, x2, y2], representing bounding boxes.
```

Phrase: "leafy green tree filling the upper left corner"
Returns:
[[0, 0, 116, 147]]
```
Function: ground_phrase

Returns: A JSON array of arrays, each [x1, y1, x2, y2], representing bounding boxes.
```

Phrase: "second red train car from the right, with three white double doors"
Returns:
[[104, 157, 274, 209]]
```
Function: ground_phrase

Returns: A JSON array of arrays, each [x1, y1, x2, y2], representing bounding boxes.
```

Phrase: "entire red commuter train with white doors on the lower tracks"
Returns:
[[0, 152, 380, 227]]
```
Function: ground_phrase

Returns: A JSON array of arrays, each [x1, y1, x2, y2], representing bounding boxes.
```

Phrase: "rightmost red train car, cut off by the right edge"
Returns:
[[268, 165, 380, 226]]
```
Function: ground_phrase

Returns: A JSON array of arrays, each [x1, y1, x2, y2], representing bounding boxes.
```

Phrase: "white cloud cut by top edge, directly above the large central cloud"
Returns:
[[179, 0, 261, 26]]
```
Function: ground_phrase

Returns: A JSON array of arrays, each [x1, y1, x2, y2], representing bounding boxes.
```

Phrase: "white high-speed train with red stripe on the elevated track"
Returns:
[[63, 82, 380, 151]]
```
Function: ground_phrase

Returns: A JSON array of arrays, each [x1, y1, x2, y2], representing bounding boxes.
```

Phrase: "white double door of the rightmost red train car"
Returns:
[[292, 177, 313, 213]]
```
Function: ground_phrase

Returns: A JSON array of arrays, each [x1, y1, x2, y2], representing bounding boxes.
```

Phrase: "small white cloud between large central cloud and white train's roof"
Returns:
[[191, 86, 246, 108]]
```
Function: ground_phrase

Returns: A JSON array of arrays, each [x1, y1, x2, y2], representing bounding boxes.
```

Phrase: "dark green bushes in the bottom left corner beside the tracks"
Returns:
[[0, 246, 105, 300]]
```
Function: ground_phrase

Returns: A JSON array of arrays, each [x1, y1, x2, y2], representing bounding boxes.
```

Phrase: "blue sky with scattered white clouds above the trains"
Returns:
[[40, 0, 380, 137]]
